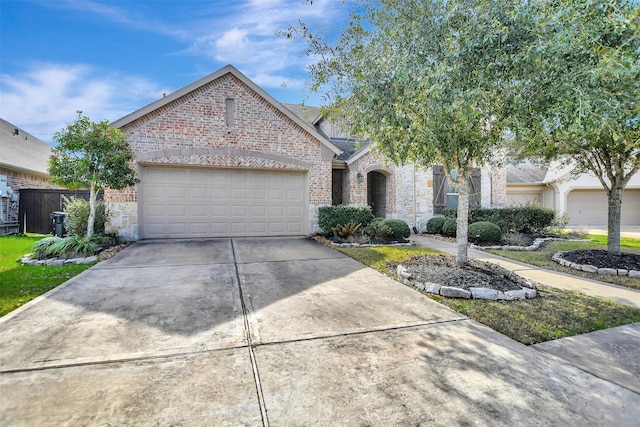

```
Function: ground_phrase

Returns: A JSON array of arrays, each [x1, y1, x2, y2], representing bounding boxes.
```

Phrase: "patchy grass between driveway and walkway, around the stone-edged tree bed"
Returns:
[[337, 242, 640, 345]]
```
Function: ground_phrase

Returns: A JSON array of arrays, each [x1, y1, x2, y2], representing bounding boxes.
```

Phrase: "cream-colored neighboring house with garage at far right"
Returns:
[[507, 162, 640, 227]]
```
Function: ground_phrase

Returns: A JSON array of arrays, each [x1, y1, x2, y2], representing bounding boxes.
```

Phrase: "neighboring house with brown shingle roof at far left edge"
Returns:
[[0, 119, 60, 234]]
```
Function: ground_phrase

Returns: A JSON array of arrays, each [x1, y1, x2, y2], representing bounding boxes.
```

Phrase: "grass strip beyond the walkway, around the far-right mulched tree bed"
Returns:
[[487, 234, 640, 289]]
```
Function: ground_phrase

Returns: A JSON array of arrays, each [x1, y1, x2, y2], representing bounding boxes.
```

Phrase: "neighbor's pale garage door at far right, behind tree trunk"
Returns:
[[567, 189, 640, 226]]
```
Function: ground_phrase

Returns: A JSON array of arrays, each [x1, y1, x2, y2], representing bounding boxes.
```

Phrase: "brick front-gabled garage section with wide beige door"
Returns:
[[105, 65, 341, 240]]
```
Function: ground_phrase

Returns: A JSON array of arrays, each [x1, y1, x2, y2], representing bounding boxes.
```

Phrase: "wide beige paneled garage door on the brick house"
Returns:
[[139, 166, 309, 239]]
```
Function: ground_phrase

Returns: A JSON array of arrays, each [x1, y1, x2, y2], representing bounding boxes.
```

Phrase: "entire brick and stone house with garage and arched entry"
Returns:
[[105, 65, 506, 240]]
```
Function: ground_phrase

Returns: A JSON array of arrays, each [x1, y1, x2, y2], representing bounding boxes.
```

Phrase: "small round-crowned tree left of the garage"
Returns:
[[49, 111, 137, 237]]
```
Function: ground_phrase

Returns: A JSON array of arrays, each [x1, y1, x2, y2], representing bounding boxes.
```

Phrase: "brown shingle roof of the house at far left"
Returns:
[[0, 119, 52, 175]]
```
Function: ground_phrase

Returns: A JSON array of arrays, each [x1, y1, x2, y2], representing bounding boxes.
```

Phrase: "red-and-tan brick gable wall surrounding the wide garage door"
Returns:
[[105, 74, 333, 239]]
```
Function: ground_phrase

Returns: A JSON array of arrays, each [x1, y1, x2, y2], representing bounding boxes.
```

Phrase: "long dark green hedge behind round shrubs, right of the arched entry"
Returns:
[[442, 206, 556, 234]]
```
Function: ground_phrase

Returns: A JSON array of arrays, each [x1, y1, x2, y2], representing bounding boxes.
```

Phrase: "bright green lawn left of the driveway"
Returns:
[[0, 236, 93, 316]]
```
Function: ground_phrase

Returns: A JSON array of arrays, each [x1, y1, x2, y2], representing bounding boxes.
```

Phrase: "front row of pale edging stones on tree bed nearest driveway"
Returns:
[[397, 265, 538, 301]]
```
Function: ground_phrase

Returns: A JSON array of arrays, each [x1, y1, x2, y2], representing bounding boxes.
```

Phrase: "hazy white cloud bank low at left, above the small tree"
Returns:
[[0, 63, 168, 141]]
